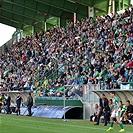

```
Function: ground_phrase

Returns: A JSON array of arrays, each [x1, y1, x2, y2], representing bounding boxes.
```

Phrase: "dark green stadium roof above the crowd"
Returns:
[[0, 0, 130, 29]]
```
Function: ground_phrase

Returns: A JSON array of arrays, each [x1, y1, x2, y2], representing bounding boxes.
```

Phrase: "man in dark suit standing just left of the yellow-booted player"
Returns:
[[95, 94, 110, 126]]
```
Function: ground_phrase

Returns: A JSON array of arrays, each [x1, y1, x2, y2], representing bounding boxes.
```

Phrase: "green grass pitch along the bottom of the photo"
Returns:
[[0, 114, 133, 133]]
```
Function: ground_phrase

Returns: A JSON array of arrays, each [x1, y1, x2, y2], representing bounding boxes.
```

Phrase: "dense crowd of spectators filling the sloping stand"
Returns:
[[0, 5, 133, 96]]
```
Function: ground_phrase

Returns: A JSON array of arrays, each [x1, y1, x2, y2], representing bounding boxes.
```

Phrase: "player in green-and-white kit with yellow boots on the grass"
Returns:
[[107, 91, 125, 132]]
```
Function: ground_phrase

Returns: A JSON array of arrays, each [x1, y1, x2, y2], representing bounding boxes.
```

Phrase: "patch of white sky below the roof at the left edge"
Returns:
[[0, 23, 16, 46]]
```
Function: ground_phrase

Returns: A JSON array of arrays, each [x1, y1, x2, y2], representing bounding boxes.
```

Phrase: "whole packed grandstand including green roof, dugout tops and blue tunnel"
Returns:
[[0, 0, 133, 132]]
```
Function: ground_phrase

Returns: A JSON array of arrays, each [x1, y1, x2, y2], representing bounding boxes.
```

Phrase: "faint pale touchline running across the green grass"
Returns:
[[1, 117, 132, 133]]
